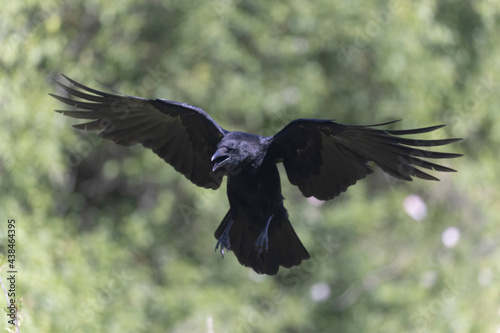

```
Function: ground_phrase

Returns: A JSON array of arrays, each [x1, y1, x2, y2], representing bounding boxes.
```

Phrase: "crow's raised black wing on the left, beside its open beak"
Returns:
[[50, 76, 227, 189]]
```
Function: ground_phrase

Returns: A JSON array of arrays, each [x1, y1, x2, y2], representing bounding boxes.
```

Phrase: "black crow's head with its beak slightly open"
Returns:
[[212, 132, 268, 175]]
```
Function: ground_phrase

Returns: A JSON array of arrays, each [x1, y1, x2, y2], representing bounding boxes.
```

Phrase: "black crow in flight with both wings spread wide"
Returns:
[[49, 75, 462, 275]]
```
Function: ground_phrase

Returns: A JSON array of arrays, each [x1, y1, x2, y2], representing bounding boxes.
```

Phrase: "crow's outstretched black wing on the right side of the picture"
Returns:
[[270, 119, 462, 200]]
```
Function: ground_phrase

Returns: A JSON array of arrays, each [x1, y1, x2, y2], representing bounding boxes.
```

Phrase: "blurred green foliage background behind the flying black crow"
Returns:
[[0, 0, 500, 333]]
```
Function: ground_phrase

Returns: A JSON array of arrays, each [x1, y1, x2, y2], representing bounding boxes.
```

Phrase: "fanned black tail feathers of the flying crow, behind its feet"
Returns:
[[215, 209, 309, 275]]
